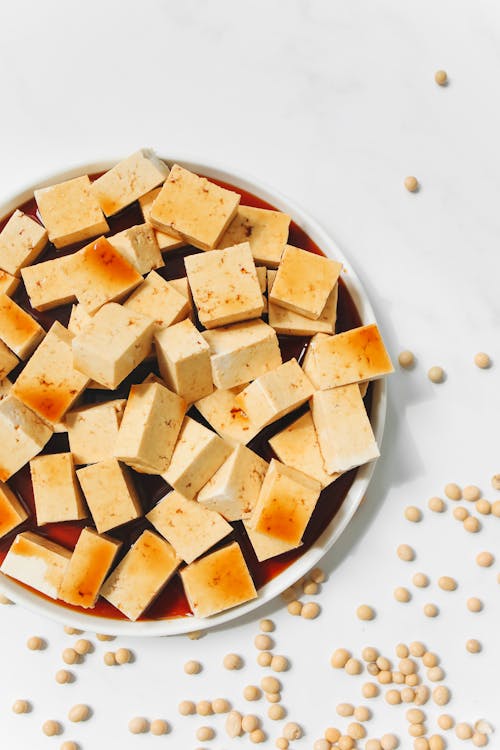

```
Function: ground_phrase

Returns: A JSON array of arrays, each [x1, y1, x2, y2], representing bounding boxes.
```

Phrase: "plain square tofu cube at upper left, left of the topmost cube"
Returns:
[[35, 175, 109, 248]]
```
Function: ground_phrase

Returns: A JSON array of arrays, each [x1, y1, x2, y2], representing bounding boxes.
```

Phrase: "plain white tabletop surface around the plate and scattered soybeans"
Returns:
[[0, 0, 500, 750]]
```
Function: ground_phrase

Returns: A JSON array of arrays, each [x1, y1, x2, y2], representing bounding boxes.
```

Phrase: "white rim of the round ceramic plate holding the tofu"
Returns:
[[0, 162, 387, 636]]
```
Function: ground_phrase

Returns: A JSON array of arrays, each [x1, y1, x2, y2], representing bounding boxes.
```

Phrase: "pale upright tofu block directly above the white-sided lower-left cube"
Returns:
[[30, 453, 87, 526]]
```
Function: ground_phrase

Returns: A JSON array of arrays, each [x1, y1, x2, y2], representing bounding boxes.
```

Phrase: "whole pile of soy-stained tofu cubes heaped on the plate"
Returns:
[[0, 149, 392, 620]]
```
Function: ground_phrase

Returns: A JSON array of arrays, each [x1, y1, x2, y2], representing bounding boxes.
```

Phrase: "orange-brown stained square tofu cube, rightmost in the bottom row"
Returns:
[[180, 542, 257, 617]]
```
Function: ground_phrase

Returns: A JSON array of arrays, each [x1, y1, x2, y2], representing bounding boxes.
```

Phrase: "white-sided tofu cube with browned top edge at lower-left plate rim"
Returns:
[[0, 531, 71, 599]]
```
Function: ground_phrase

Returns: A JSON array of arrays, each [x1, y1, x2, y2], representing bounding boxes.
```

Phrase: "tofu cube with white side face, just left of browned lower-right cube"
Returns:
[[197, 445, 268, 521]]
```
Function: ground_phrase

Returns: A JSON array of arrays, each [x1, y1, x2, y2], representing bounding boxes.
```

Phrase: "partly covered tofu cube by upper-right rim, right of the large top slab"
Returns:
[[217, 206, 290, 268]]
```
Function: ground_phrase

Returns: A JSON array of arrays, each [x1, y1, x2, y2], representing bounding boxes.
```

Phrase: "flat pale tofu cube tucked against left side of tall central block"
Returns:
[[64, 399, 127, 465]]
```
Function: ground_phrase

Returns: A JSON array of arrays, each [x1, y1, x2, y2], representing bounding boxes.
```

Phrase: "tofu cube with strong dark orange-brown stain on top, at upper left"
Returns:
[[72, 237, 143, 315]]
